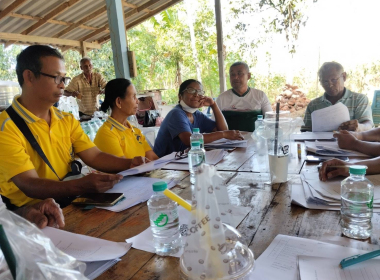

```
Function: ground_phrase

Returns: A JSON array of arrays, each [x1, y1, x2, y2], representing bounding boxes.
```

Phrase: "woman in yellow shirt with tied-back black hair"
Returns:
[[94, 78, 158, 160]]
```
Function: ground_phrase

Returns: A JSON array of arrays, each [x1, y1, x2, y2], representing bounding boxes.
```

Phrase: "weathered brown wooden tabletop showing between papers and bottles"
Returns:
[[63, 133, 380, 280]]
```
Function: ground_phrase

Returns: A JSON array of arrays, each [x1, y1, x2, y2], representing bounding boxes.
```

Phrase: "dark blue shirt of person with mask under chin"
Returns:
[[153, 105, 216, 157]]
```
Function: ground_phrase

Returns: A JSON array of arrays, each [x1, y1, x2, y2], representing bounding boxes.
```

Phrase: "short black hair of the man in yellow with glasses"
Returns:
[[16, 45, 64, 87]]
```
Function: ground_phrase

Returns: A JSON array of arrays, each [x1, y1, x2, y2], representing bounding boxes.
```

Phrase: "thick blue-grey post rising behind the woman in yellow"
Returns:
[[106, 0, 131, 79]]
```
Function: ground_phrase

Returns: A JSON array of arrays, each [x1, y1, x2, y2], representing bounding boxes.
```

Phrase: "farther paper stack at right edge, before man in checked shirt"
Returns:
[[305, 141, 368, 157]]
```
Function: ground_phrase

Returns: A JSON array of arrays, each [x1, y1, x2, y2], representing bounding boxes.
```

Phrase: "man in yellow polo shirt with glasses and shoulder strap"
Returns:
[[0, 45, 143, 207]]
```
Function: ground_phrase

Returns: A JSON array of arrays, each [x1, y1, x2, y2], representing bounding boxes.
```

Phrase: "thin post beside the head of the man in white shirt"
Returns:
[[215, 0, 227, 93]]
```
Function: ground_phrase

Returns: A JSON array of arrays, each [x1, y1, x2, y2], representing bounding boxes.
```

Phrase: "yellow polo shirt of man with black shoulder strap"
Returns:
[[0, 96, 95, 206]]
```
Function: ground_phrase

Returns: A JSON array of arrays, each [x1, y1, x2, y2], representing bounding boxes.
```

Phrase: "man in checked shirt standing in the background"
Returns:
[[64, 57, 107, 117]]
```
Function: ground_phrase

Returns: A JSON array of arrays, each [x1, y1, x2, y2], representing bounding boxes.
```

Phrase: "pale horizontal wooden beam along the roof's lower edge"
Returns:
[[0, 32, 101, 49]]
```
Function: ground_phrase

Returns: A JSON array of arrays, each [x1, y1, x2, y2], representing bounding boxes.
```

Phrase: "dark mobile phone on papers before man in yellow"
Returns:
[[71, 193, 124, 206]]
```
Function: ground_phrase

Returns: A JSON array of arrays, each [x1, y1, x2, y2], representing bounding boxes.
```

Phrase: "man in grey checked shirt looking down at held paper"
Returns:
[[301, 62, 373, 131]]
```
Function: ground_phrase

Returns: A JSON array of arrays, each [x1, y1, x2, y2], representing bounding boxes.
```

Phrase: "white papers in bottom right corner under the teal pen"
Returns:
[[249, 235, 380, 280]]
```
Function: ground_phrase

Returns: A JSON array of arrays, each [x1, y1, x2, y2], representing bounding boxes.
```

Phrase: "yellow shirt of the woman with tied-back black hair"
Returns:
[[94, 117, 152, 158]]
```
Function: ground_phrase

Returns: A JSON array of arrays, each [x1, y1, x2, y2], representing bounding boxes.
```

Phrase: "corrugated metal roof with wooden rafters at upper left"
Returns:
[[0, 0, 181, 49]]
